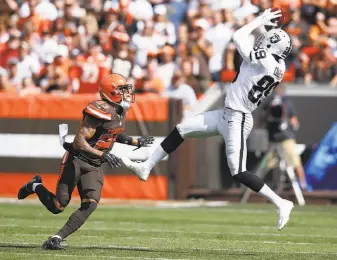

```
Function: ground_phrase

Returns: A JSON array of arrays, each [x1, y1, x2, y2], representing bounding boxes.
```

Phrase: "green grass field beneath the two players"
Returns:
[[0, 204, 337, 260]]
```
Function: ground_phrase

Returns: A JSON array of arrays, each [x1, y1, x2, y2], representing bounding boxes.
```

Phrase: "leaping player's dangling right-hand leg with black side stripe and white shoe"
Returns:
[[222, 110, 293, 230]]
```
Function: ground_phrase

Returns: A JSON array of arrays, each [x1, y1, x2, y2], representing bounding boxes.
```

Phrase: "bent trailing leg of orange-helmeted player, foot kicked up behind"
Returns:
[[18, 152, 76, 214]]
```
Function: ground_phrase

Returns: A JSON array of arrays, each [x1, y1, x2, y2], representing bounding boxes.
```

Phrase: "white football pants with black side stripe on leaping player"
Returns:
[[177, 107, 253, 175]]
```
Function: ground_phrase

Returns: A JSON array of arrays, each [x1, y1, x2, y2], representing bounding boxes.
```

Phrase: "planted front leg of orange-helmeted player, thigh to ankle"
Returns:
[[52, 162, 103, 242]]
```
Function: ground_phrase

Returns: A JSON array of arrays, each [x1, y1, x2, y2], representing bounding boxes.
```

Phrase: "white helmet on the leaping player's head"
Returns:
[[254, 29, 292, 59]]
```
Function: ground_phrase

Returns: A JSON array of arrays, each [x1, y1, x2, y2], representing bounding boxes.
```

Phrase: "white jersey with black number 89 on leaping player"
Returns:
[[225, 47, 285, 113]]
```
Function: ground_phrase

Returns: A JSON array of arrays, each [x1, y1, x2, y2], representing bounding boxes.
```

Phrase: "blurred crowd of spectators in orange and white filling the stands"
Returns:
[[0, 0, 337, 106]]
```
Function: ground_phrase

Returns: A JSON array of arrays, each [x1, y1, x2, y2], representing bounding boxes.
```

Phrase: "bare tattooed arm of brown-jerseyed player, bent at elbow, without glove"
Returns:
[[73, 115, 103, 158]]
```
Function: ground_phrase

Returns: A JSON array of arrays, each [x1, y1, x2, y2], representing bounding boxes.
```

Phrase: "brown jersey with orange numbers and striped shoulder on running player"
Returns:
[[76, 100, 125, 165]]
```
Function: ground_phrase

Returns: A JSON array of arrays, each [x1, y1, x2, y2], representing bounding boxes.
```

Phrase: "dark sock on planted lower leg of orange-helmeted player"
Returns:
[[56, 202, 97, 239]]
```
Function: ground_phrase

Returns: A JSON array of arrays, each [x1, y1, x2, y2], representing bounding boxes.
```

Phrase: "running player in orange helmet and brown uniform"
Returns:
[[18, 73, 154, 250]]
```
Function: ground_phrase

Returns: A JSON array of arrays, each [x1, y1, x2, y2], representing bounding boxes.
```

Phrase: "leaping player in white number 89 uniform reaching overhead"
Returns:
[[121, 9, 294, 230]]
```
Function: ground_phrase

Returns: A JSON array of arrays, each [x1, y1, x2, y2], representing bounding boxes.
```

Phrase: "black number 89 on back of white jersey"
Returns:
[[248, 75, 280, 106]]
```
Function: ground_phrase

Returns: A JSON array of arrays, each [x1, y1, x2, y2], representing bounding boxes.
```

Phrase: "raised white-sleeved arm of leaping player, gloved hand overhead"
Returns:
[[233, 9, 282, 63]]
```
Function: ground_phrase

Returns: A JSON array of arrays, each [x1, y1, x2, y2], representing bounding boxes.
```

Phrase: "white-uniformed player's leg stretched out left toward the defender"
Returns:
[[122, 110, 223, 181]]
